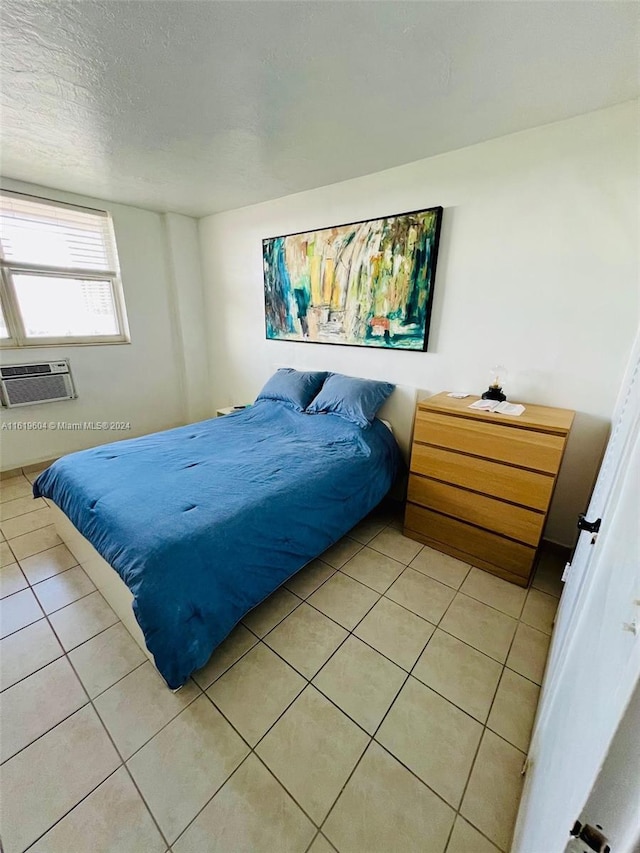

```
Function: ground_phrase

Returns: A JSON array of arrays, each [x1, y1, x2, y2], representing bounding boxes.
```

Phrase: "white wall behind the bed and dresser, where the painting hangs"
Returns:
[[200, 103, 638, 544]]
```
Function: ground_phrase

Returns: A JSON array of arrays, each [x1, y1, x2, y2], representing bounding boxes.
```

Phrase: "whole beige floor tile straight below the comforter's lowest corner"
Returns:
[[128, 696, 249, 844]]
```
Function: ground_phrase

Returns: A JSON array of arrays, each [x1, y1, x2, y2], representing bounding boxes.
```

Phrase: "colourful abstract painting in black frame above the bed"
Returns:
[[262, 207, 442, 351]]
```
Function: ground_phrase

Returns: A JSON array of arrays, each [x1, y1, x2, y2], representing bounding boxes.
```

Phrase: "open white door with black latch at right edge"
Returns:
[[512, 340, 640, 853]]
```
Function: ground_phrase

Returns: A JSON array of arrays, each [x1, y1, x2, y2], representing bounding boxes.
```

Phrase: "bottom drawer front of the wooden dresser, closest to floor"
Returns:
[[405, 503, 536, 578]]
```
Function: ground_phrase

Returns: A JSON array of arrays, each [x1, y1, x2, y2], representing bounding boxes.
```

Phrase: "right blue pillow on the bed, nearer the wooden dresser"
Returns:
[[307, 373, 396, 427]]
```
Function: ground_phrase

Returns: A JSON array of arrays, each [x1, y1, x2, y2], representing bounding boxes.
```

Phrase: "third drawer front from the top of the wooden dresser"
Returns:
[[408, 474, 545, 547]]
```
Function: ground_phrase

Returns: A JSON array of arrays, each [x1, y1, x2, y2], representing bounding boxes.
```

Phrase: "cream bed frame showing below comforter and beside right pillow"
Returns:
[[48, 385, 417, 667]]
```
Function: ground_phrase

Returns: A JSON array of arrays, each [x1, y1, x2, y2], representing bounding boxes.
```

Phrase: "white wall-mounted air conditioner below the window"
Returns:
[[0, 358, 78, 409]]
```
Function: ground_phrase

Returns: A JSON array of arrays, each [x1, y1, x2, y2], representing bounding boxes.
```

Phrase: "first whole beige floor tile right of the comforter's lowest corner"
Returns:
[[207, 643, 306, 746]]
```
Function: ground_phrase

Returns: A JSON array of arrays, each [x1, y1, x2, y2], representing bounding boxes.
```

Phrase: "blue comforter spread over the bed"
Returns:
[[34, 401, 399, 688]]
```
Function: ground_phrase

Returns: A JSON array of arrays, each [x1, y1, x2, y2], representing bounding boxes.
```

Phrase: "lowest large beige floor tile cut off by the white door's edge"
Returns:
[[460, 729, 525, 851]]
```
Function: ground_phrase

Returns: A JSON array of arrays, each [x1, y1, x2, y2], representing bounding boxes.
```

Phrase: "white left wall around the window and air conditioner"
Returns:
[[0, 179, 208, 470]]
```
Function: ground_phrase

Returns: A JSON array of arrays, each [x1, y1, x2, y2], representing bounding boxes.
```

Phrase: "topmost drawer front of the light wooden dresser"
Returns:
[[414, 411, 565, 474]]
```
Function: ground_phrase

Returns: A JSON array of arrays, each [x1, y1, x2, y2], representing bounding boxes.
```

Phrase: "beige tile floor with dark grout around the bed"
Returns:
[[0, 472, 561, 853]]
